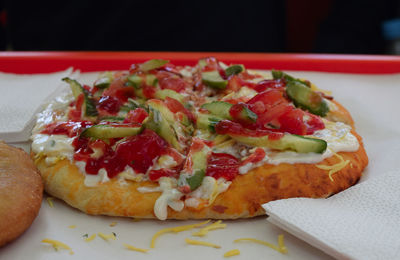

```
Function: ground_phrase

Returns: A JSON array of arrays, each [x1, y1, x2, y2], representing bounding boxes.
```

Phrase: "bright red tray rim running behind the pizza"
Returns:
[[0, 52, 400, 74]]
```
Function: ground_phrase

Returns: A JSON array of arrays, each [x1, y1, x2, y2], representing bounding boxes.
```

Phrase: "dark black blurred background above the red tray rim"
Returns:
[[0, 0, 400, 54]]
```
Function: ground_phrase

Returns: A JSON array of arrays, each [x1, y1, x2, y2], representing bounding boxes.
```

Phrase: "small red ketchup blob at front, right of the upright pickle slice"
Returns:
[[206, 153, 239, 181]]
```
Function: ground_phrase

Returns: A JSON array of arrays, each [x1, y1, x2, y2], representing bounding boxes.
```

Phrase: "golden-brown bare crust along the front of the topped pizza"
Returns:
[[32, 132, 368, 219]]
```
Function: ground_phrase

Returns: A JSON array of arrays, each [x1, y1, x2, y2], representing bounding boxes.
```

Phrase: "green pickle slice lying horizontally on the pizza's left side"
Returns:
[[81, 125, 142, 139]]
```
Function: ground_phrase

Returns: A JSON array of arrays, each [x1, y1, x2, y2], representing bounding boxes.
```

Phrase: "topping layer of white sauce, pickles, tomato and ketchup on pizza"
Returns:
[[32, 57, 359, 219]]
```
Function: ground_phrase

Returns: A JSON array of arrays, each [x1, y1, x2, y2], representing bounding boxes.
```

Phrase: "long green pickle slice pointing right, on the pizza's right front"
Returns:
[[228, 134, 327, 153]]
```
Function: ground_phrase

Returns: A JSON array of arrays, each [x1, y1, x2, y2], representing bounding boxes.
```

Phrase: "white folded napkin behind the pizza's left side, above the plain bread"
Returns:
[[0, 68, 72, 142]]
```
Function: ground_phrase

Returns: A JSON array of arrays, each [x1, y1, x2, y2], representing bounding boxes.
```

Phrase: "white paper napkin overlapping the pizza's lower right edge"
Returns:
[[263, 169, 400, 259]]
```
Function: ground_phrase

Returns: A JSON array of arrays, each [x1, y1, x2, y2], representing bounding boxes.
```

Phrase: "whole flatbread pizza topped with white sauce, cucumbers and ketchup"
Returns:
[[32, 57, 368, 220]]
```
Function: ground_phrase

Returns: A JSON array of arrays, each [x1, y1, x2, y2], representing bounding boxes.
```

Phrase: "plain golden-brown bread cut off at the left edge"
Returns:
[[0, 142, 43, 246]]
